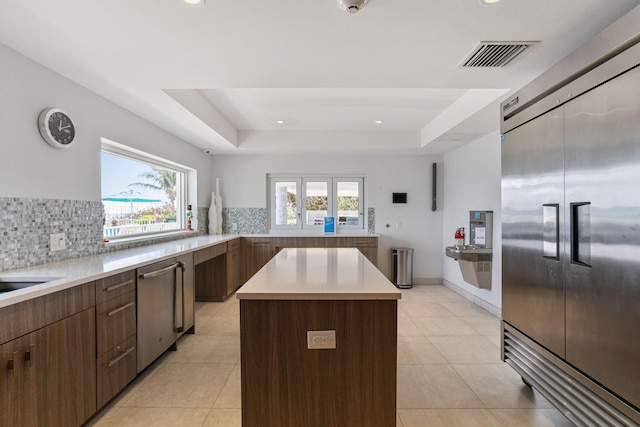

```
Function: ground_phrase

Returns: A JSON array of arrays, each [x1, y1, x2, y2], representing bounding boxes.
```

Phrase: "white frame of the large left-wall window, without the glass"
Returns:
[[100, 138, 193, 242]]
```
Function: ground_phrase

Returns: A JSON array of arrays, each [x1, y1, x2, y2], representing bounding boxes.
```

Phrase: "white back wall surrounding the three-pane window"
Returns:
[[209, 155, 443, 283]]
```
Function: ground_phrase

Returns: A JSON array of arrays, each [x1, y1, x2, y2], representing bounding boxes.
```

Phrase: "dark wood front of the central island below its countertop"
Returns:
[[240, 299, 398, 427]]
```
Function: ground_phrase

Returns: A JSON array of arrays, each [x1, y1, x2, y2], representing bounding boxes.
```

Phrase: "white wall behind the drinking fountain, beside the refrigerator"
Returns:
[[441, 131, 502, 308]]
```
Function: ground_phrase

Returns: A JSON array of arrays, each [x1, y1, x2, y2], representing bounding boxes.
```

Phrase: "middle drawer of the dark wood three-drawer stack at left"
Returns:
[[96, 292, 136, 356]]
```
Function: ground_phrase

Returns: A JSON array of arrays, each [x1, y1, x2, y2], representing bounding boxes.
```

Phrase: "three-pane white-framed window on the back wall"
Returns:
[[268, 175, 364, 230]]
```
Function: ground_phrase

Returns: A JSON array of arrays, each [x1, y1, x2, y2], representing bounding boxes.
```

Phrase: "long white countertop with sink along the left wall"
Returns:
[[0, 234, 240, 308]]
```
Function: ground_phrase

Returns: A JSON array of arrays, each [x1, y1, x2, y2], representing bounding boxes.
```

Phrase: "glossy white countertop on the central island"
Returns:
[[236, 248, 402, 300]]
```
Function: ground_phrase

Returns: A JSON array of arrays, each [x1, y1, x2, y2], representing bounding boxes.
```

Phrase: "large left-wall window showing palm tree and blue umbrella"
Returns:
[[101, 139, 190, 240]]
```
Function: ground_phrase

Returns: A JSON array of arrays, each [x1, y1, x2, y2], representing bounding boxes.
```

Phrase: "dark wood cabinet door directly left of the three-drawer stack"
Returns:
[[31, 308, 96, 427]]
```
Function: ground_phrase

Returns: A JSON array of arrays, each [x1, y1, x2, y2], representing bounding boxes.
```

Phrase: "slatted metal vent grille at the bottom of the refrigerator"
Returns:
[[504, 330, 636, 427]]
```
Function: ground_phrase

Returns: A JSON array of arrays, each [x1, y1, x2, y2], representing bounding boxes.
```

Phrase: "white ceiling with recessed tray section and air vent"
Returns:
[[0, 0, 640, 155]]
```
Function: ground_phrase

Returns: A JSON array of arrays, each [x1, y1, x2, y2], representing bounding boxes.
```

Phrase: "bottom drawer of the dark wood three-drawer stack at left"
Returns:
[[97, 335, 136, 409]]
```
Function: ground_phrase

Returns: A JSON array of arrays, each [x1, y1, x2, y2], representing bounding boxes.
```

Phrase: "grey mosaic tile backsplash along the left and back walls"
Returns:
[[0, 197, 375, 271]]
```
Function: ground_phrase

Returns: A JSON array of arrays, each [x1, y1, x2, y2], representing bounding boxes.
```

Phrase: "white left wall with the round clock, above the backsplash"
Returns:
[[0, 45, 212, 207]]
